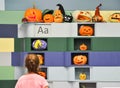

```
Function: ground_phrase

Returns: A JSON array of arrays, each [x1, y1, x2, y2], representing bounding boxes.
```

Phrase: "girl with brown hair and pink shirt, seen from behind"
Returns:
[[15, 54, 48, 88]]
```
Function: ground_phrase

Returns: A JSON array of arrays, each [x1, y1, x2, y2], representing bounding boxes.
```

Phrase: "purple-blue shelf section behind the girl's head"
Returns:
[[11, 52, 65, 66]]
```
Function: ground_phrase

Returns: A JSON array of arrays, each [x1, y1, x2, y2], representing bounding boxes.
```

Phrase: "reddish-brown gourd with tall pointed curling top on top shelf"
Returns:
[[92, 4, 103, 22]]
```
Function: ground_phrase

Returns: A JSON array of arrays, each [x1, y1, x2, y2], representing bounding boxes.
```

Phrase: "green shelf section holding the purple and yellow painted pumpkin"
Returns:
[[15, 37, 67, 52]]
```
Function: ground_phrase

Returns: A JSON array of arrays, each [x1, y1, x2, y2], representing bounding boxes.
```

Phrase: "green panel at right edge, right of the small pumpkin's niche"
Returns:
[[92, 37, 120, 51]]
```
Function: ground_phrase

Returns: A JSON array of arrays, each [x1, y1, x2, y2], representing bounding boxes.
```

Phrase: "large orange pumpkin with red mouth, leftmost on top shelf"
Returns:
[[24, 6, 42, 22]]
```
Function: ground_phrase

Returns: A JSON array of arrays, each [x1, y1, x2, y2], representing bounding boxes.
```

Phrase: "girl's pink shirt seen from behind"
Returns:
[[15, 74, 48, 88]]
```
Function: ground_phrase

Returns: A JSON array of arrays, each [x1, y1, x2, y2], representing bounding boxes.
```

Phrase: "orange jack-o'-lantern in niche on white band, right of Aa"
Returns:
[[79, 25, 94, 36]]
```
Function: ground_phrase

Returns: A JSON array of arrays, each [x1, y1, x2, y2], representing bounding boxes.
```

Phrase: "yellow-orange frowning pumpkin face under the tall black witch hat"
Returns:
[[54, 10, 63, 23]]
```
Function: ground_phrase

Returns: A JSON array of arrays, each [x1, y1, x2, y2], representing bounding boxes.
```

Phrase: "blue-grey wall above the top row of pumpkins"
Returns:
[[5, 0, 120, 10]]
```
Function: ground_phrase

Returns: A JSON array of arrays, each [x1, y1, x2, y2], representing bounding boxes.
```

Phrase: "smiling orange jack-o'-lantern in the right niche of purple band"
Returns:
[[73, 55, 87, 65]]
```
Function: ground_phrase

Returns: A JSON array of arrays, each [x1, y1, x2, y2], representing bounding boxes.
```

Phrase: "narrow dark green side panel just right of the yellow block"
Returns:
[[14, 38, 24, 52]]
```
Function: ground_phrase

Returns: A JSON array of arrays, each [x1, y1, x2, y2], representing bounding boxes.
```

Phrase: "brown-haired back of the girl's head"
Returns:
[[25, 54, 39, 73]]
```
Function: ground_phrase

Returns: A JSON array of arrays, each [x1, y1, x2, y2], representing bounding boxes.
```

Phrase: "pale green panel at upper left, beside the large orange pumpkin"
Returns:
[[0, 11, 24, 24]]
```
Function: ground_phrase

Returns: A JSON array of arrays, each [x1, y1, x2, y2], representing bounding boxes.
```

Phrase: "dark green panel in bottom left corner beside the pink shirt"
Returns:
[[0, 80, 17, 88]]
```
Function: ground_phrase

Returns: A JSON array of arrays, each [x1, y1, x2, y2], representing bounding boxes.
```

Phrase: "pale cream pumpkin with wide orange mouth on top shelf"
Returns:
[[72, 10, 92, 22]]
